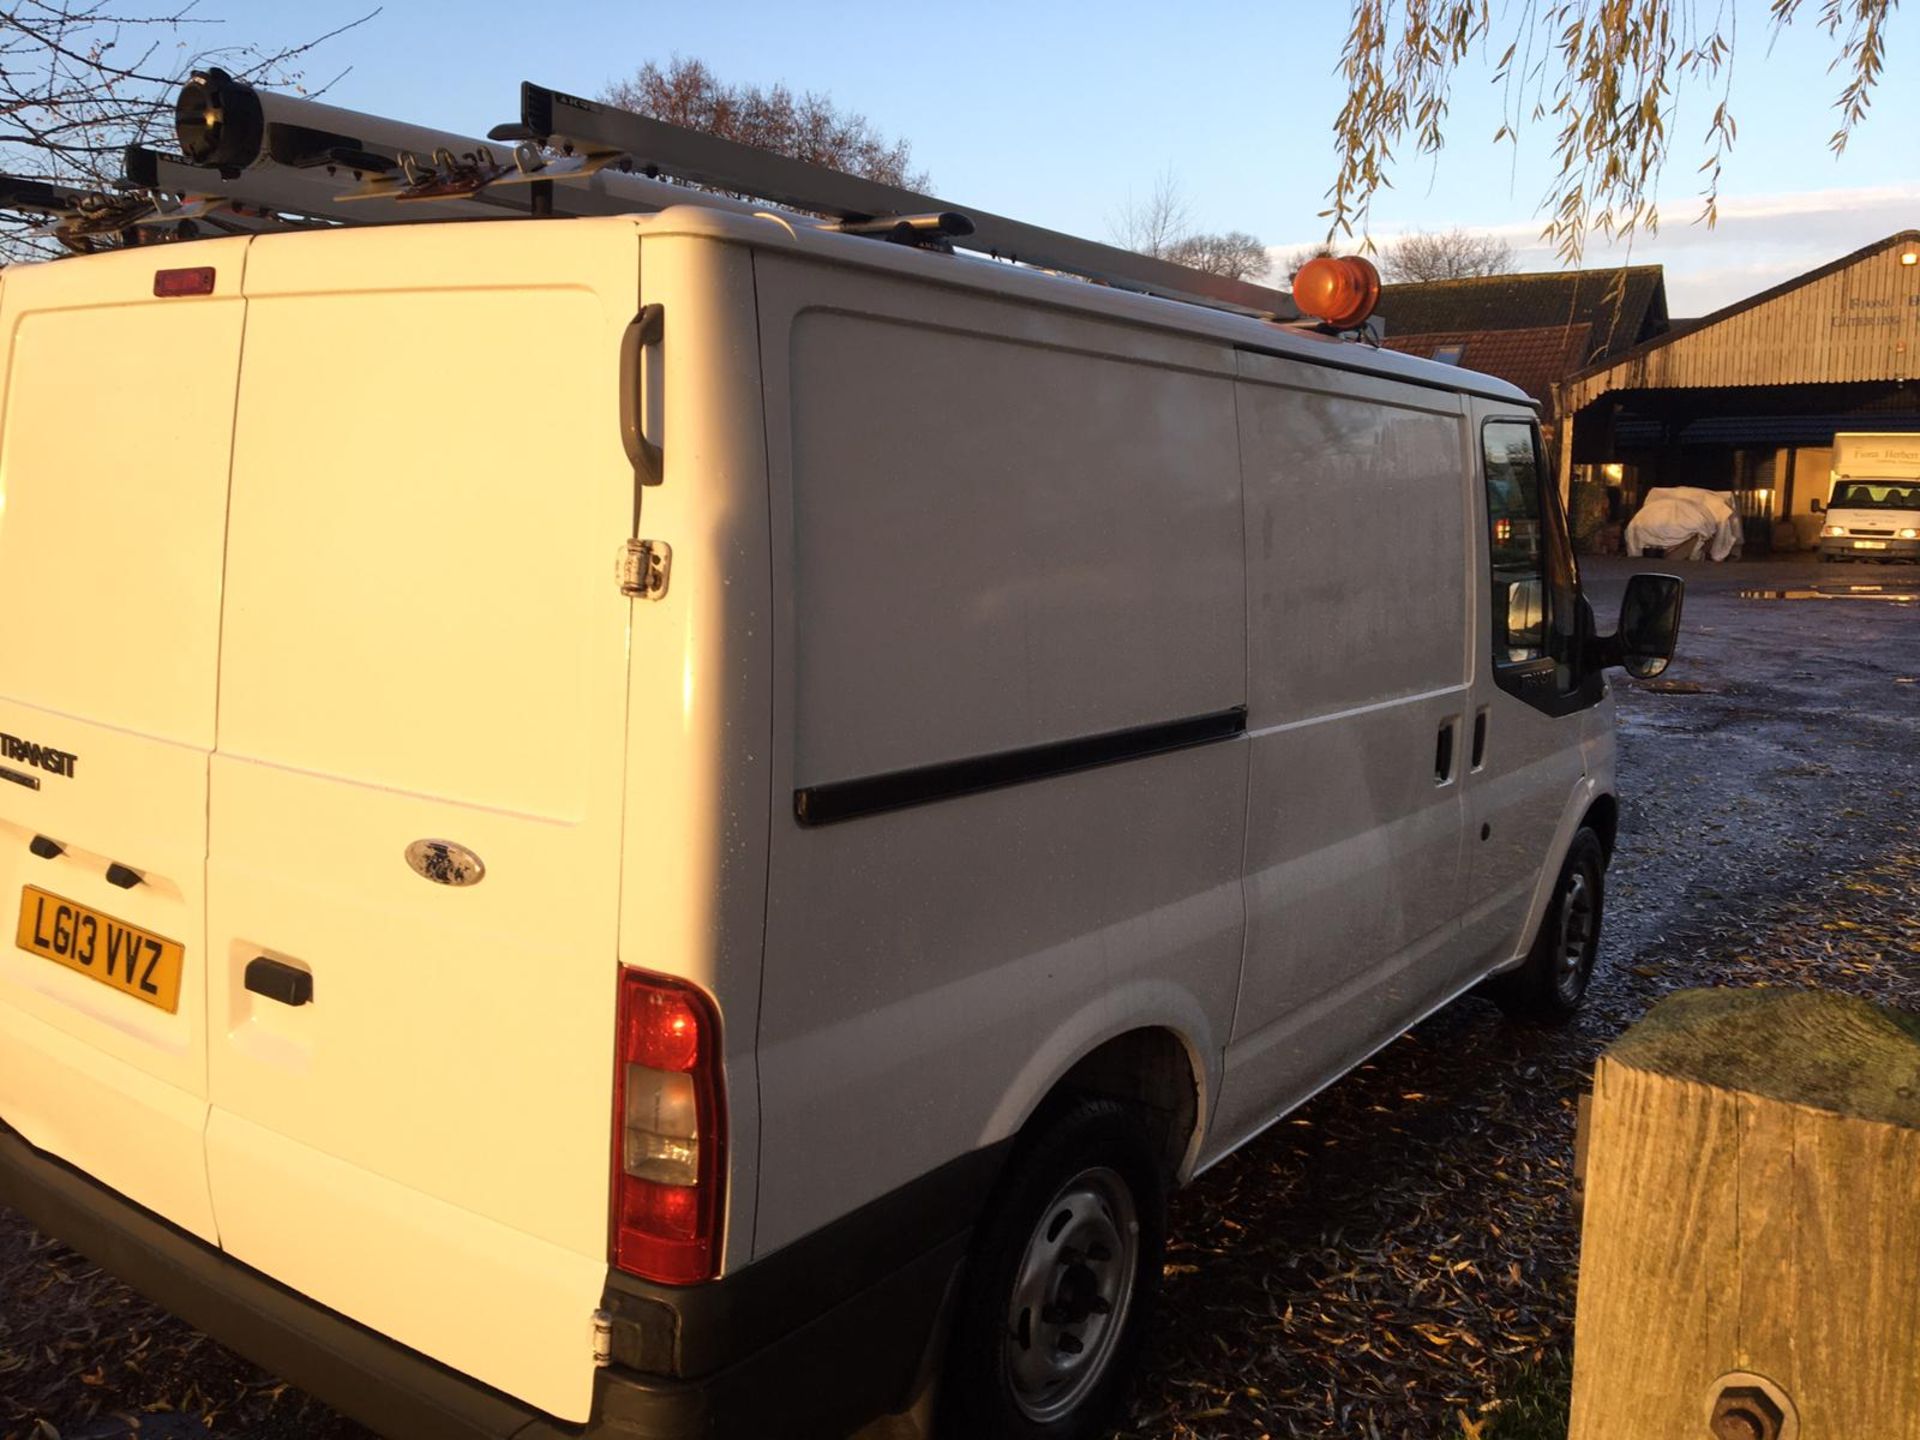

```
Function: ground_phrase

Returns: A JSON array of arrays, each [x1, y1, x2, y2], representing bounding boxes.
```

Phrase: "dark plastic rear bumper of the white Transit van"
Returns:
[[0, 1125, 998, 1440]]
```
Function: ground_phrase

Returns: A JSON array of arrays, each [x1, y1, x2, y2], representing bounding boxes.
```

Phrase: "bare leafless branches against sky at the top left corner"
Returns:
[[0, 0, 380, 259]]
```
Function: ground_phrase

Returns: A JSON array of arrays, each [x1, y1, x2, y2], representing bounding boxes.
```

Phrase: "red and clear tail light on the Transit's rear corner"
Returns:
[[611, 970, 726, 1284]]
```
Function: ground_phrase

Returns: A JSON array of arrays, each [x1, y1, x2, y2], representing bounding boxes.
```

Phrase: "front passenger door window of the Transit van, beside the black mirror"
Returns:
[[1482, 420, 1601, 714]]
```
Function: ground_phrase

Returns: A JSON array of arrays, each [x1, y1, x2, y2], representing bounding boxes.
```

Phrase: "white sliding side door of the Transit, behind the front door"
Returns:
[[1212, 355, 1473, 1142]]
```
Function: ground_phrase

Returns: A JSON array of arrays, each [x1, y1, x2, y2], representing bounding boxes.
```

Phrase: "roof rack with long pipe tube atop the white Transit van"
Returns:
[[0, 69, 1300, 321]]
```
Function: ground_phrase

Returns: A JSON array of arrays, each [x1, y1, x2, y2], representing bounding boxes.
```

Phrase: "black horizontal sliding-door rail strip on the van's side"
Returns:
[[793, 705, 1246, 826]]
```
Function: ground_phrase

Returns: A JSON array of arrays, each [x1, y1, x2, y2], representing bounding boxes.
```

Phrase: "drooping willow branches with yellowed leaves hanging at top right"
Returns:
[[1327, 0, 1899, 263]]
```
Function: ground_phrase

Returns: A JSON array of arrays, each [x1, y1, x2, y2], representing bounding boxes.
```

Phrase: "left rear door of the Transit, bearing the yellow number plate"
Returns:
[[0, 240, 248, 1240]]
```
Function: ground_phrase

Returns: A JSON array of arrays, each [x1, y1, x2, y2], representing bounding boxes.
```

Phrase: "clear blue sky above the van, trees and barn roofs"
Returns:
[[192, 0, 1920, 315]]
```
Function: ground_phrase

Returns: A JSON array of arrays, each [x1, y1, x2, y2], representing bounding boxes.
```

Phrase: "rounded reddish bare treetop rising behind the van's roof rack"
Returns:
[[601, 56, 929, 190]]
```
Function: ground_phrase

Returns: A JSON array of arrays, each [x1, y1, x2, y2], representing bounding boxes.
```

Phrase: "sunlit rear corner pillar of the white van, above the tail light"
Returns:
[[620, 236, 774, 1271]]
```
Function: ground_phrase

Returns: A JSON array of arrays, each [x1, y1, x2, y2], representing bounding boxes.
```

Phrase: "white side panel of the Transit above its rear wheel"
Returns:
[[755, 253, 1246, 1254]]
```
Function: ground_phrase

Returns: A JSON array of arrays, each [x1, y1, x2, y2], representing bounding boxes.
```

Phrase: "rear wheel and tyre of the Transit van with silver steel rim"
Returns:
[[941, 1098, 1167, 1440]]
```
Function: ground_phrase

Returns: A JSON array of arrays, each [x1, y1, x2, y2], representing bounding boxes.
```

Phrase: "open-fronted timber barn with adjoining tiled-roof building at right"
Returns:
[[1379, 230, 1920, 551]]
